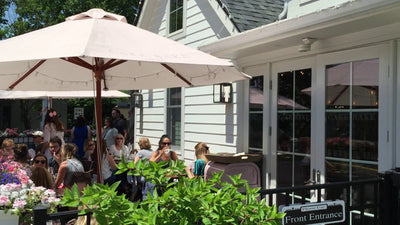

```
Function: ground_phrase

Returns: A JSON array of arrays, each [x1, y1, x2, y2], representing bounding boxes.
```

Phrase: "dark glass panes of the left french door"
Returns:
[[277, 69, 311, 191]]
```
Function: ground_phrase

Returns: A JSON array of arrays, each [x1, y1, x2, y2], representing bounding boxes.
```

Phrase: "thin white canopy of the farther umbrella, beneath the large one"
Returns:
[[0, 90, 130, 99]]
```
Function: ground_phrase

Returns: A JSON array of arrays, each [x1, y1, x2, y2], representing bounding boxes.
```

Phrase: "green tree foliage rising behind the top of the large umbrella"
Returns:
[[0, 0, 139, 38]]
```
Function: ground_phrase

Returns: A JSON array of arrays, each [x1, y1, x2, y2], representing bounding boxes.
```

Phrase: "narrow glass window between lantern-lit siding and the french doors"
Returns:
[[249, 76, 264, 151]]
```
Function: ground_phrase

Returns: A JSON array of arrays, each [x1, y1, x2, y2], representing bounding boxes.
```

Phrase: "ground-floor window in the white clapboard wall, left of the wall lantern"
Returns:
[[167, 88, 182, 146]]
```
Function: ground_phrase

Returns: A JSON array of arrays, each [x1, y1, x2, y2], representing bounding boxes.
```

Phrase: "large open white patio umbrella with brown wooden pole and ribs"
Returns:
[[0, 9, 250, 180]]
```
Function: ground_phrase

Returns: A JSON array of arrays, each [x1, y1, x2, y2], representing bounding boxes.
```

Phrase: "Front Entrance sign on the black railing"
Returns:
[[280, 200, 346, 225]]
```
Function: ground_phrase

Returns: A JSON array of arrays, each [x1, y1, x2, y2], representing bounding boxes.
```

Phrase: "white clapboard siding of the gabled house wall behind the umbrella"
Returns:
[[136, 0, 238, 162]]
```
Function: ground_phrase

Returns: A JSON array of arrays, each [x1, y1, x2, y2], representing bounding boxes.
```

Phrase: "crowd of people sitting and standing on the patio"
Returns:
[[0, 109, 209, 201]]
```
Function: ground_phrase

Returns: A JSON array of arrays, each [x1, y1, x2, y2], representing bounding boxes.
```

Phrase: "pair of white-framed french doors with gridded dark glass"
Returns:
[[270, 46, 392, 206]]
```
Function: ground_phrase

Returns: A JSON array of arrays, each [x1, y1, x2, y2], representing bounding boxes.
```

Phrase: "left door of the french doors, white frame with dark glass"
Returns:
[[270, 60, 313, 205]]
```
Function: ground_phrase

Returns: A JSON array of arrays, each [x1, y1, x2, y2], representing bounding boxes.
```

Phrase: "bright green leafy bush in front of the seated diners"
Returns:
[[62, 161, 284, 225]]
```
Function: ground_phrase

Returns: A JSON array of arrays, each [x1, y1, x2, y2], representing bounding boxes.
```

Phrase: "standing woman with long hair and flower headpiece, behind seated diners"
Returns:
[[43, 109, 65, 144]]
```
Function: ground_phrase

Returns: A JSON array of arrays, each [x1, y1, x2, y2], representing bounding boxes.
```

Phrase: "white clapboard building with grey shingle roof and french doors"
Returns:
[[136, 0, 400, 192]]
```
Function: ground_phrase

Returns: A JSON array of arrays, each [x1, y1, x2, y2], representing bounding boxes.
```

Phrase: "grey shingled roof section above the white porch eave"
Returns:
[[217, 0, 284, 32]]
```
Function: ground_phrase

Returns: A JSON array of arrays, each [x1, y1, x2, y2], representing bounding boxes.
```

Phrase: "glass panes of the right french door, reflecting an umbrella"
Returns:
[[325, 59, 379, 182]]
